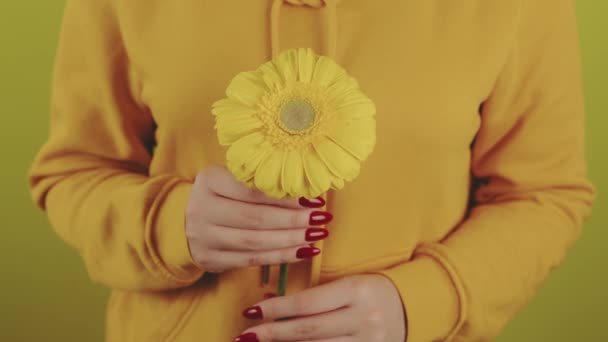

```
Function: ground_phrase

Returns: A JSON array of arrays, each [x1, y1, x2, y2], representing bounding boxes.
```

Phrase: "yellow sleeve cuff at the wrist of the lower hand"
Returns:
[[377, 249, 465, 342]]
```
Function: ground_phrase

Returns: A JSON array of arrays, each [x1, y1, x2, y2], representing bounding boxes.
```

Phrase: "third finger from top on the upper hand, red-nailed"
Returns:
[[208, 226, 329, 251]]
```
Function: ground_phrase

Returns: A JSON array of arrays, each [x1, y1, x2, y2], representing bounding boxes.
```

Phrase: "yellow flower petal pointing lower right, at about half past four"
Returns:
[[314, 139, 361, 182]]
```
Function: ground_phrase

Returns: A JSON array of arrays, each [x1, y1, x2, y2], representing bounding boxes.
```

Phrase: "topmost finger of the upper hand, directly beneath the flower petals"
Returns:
[[207, 166, 303, 209]]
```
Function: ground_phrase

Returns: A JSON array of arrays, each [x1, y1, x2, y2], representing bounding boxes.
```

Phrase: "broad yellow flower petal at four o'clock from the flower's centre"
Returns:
[[328, 119, 376, 161]]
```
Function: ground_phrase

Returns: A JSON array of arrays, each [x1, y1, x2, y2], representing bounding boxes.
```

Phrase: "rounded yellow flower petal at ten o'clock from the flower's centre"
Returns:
[[226, 71, 268, 107]]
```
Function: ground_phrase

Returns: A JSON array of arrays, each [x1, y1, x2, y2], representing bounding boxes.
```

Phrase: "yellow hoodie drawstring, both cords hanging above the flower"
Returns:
[[270, 0, 338, 59]]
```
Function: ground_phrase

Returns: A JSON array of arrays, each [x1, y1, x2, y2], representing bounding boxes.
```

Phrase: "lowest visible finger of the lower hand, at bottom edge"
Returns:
[[245, 308, 358, 342]]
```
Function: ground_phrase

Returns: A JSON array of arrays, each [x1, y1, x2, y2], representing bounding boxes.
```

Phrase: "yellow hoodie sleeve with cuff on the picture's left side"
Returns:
[[29, 0, 202, 289]]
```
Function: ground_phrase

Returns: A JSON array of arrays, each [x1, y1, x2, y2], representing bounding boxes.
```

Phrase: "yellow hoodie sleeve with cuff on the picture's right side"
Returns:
[[381, 0, 594, 342]]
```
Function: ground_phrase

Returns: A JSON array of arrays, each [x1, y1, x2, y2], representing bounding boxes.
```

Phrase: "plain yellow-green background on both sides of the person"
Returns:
[[0, 0, 608, 342]]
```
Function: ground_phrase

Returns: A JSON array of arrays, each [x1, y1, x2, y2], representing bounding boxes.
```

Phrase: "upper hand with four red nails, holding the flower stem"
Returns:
[[186, 166, 332, 272]]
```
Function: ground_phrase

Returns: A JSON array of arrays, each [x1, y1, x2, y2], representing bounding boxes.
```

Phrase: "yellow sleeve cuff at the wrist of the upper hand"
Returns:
[[153, 183, 204, 284]]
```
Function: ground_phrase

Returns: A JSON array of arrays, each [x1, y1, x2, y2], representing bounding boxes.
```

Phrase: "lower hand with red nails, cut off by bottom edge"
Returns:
[[234, 274, 406, 342]]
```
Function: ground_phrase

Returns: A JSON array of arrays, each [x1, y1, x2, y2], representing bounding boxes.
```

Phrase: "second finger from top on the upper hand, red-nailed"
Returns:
[[205, 197, 332, 229]]
